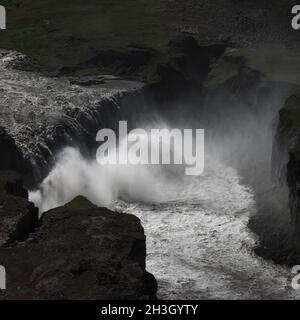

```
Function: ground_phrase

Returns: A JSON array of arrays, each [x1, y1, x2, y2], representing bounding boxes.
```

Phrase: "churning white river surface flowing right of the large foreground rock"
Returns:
[[116, 164, 300, 299]]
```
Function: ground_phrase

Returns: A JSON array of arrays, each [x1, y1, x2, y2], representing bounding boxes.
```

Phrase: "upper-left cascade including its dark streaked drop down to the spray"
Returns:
[[0, 50, 141, 185]]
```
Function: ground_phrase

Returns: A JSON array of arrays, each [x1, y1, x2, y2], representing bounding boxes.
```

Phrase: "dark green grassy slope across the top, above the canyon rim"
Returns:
[[0, 0, 298, 82]]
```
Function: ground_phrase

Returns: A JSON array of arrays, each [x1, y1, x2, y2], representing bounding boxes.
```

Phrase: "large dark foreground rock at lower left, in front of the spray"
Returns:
[[0, 197, 156, 299]]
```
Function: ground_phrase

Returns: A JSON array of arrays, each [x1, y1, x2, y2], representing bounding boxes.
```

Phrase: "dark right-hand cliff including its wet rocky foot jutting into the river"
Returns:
[[250, 88, 300, 266]]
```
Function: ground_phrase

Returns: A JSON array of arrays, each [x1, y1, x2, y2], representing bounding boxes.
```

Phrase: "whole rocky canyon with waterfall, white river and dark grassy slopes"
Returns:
[[0, 0, 300, 299]]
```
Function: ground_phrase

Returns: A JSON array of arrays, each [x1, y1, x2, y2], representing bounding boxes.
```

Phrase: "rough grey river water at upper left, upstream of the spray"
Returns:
[[0, 49, 141, 166]]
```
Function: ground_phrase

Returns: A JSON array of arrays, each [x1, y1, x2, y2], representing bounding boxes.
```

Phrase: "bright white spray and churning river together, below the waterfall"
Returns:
[[30, 148, 300, 299]]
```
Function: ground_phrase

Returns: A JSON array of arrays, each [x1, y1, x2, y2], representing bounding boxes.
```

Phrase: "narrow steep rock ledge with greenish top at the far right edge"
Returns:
[[269, 88, 300, 266]]
